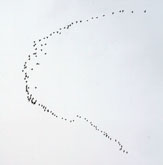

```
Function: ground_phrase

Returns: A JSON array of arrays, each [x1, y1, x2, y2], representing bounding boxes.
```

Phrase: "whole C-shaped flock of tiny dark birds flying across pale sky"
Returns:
[[22, 10, 146, 154]]
